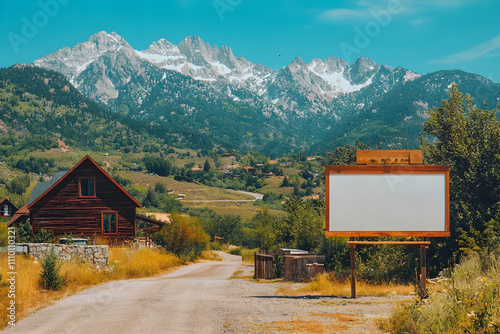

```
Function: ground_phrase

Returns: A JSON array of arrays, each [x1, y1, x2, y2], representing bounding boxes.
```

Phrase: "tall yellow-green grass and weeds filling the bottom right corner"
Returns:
[[380, 250, 500, 334]]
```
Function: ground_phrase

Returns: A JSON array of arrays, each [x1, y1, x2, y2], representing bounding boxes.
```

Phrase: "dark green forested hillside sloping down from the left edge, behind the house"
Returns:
[[0, 66, 178, 159]]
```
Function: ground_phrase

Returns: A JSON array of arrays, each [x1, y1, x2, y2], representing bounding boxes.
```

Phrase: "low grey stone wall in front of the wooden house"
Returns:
[[17, 243, 109, 267]]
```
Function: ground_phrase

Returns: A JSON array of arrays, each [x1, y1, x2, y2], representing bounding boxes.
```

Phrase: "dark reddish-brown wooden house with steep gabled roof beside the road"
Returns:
[[8, 156, 141, 240]]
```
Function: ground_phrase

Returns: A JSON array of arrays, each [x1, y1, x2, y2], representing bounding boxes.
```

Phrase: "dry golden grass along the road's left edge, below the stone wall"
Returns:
[[0, 248, 181, 329]]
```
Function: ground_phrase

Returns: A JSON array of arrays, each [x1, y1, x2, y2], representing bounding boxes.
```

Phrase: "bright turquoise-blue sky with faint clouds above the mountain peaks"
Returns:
[[0, 0, 500, 82]]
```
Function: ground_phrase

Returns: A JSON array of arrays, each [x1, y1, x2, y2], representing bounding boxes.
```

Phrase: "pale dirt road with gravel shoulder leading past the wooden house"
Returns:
[[5, 253, 402, 334]]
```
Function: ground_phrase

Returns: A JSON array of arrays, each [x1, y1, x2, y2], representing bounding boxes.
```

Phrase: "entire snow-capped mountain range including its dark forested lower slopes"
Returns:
[[32, 31, 500, 153]]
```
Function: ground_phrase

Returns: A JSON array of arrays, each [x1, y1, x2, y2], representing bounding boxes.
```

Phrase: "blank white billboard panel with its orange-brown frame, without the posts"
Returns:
[[325, 165, 450, 237]]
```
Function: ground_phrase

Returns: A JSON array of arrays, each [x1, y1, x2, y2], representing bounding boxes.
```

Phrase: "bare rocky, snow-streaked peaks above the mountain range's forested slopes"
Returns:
[[33, 31, 420, 110]]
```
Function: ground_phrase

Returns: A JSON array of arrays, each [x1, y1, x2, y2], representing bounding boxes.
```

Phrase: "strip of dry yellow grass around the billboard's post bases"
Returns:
[[276, 274, 414, 297]]
